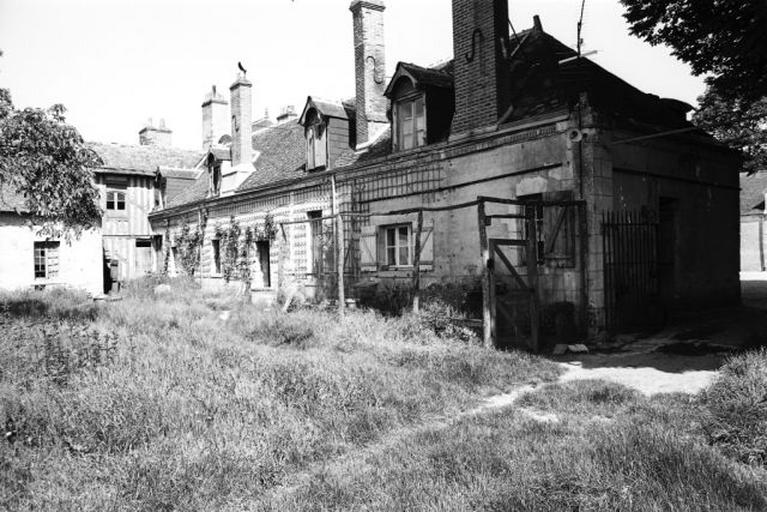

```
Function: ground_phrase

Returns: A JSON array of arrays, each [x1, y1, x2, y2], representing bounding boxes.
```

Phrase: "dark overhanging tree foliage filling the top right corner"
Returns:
[[621, 0, 767, 102]]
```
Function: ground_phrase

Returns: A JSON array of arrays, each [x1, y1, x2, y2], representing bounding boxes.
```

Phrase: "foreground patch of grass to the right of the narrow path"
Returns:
[[280, 381, 767, 511]]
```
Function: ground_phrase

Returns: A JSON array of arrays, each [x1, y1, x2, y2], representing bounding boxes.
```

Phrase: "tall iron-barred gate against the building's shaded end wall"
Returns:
[[602, 211, 662, 332]]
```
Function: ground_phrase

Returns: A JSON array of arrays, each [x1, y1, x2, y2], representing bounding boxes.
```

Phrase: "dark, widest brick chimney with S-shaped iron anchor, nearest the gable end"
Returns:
[[451, 0, 509, 134]]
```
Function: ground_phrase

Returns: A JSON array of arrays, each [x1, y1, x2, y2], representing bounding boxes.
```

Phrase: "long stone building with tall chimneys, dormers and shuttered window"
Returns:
[[149, 0, 739, 346]]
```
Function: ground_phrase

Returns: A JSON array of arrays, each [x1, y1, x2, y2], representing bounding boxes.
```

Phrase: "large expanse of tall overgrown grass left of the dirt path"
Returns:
[[0, 286, 558, 510]]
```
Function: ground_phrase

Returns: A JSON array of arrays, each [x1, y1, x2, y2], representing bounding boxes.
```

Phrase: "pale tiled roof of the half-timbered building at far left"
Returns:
[[88, 142, 205, 174]]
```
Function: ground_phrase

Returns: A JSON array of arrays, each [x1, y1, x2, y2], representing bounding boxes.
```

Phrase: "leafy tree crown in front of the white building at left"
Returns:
[[0, 89, 103, 235]]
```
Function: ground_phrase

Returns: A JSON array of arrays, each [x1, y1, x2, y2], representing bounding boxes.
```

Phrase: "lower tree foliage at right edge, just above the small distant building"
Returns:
[[693, 87, 767, 173]]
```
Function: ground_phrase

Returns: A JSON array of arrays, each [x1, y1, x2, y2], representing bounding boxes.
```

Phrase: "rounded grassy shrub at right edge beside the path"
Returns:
[[700, 348, 767, 466]]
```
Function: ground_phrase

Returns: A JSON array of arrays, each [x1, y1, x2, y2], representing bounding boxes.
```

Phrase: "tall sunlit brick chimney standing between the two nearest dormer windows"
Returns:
[[349, 0, 388, 146]]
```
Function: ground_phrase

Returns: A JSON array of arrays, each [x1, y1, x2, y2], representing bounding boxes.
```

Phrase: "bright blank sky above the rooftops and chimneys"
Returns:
[[0, 0, 704, 148]]
